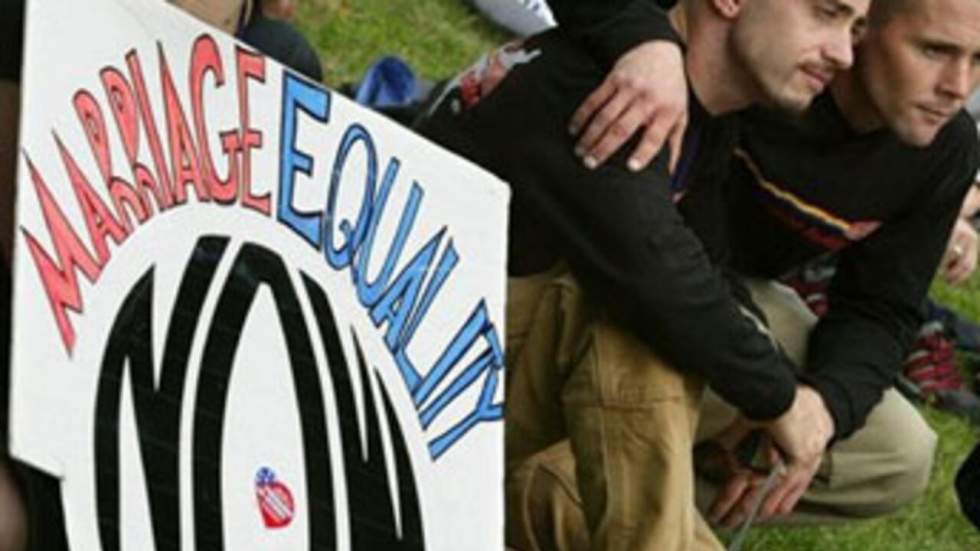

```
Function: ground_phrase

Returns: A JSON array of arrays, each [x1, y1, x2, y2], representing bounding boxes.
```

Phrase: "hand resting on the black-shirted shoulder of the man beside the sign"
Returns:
[[569, 41, 687, 172]]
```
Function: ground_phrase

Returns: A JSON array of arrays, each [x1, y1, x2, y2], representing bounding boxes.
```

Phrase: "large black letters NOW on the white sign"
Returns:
[[95, 237, 425, 551]]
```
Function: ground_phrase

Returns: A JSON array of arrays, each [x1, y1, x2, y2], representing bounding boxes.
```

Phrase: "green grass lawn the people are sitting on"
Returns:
[[297, 0, 980, 551]]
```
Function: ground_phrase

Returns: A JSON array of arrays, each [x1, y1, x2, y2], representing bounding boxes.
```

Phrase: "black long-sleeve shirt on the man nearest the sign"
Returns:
[[420, 30, 796, 419]]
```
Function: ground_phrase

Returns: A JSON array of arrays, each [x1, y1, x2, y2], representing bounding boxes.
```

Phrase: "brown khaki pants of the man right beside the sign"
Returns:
[[505, 273, 721, 551]]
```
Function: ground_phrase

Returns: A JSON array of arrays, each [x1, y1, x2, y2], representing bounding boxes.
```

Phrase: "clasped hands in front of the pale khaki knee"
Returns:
[[710, 386, 834, 527]]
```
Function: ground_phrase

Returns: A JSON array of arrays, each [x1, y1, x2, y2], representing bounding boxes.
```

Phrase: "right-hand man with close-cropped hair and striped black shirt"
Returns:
[[522, 0, 980, 541]]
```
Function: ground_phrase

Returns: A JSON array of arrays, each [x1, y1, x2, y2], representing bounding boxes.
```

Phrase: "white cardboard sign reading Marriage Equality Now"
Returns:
[[11, 0, 508, 551]]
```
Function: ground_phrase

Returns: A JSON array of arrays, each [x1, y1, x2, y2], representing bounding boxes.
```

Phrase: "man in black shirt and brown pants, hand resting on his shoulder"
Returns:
[[421, 0, 868, 550]]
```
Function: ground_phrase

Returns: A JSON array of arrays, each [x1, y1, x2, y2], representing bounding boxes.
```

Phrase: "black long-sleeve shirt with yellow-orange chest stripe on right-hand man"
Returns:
[[553, 0, 978, 438]]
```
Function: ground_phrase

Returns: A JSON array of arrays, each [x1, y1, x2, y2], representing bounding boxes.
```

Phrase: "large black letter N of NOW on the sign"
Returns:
[[95, 237, 228, 551]]
